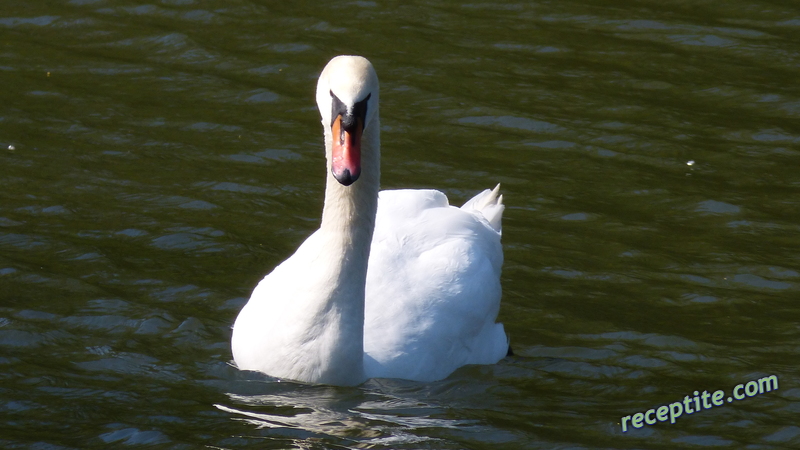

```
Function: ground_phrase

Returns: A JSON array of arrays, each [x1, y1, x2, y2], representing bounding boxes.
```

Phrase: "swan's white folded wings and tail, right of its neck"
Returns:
[[364, 188, 508, 381]]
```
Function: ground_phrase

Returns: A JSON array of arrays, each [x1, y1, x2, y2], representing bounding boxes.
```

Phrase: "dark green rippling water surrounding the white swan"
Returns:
[[0, 0, 800, 449]]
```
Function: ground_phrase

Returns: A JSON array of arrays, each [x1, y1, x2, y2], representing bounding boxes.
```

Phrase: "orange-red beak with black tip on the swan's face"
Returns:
[[331, 114, 364, 186]]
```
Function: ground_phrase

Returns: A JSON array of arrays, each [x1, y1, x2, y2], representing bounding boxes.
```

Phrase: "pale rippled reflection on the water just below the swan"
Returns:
[[214, 380, 479, 447]]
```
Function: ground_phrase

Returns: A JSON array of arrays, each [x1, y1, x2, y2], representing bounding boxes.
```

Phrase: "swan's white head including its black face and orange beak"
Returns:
[[317, 56, 379, 186]]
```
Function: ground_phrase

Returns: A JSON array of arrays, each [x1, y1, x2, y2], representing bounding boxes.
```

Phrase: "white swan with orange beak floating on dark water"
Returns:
[[231, 56, 508, 385]]
